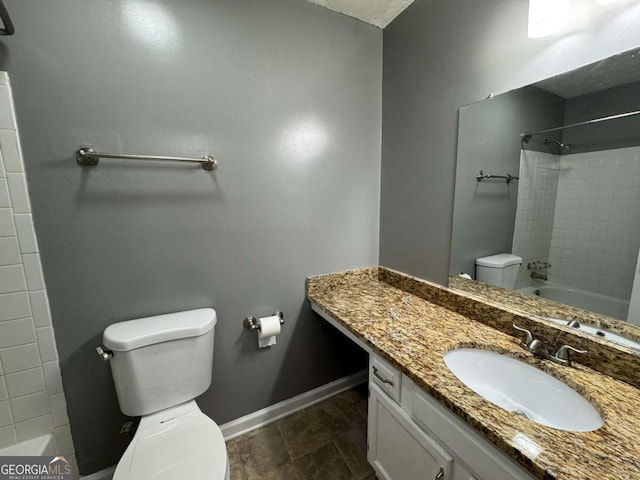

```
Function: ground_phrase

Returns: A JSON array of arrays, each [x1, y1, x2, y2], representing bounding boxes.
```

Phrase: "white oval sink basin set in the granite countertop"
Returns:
[[444, 348, 603, 432]]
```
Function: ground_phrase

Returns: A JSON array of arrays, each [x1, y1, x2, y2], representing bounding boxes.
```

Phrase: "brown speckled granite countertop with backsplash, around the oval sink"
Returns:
[[307, 267, 640, 480]]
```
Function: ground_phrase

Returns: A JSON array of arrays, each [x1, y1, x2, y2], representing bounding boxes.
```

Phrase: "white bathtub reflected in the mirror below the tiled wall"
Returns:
[[518, 284, 629, 320]]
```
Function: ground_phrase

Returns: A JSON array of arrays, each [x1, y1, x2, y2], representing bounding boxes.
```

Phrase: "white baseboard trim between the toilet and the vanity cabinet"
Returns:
[[220, 370, 369, 440]]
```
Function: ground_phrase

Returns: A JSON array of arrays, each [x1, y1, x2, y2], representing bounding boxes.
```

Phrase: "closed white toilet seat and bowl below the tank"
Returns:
[[113, 400, 229, 480]]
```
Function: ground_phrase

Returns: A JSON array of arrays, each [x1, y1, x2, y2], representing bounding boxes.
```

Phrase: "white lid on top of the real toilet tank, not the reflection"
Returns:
[[102, 308, 216, 352]]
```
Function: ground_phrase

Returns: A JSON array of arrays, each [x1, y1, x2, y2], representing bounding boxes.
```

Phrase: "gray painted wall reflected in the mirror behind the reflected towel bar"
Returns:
[[450, 87, 565, 278]]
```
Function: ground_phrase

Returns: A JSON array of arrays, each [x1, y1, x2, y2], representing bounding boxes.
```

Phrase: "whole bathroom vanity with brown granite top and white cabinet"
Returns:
[[307, 267, 640, 480]]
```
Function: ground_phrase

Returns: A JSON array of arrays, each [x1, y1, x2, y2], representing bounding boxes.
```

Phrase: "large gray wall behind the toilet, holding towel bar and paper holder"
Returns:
[[0, 0, 382, 474]]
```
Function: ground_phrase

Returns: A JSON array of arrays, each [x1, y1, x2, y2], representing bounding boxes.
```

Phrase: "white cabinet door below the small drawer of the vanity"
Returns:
[[367, 383, 453, 480]]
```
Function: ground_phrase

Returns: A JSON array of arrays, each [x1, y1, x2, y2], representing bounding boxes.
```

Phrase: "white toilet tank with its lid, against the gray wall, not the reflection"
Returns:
[[103, 308, 216, 417]]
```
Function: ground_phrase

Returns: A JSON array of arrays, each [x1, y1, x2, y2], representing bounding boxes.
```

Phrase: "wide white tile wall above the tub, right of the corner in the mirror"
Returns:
[[549, 147, 640, 299]]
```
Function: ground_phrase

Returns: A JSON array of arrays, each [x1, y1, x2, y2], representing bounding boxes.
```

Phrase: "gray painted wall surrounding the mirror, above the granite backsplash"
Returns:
[[380, 0, 640, 284]]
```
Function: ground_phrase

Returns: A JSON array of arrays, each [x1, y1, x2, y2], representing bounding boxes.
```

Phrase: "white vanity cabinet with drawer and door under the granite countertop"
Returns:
[[367, 353, 534, 480]]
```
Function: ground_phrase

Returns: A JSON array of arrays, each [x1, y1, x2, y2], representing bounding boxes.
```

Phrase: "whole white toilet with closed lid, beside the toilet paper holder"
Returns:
[[103, 308, 230, 480]]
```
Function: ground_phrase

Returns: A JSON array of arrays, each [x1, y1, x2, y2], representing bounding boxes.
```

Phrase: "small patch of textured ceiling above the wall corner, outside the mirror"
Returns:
[[307, 0, 414, 28]]
